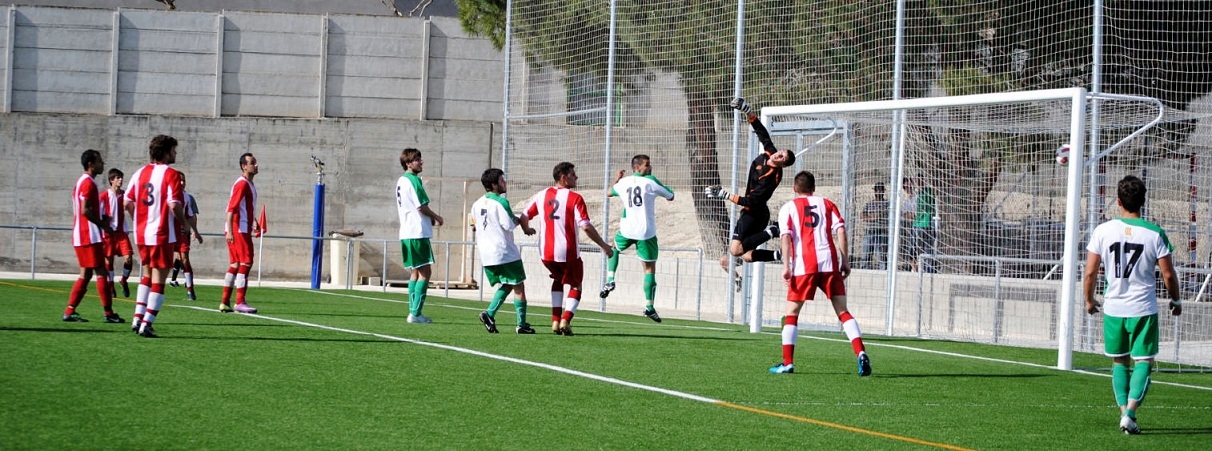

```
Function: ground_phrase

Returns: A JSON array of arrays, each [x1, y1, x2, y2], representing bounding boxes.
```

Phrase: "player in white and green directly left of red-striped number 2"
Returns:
[[471, 167, 534, 335]]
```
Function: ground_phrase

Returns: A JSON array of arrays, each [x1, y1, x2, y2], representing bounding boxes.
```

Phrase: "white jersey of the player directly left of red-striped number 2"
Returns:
[[471, 193, 522, 267]]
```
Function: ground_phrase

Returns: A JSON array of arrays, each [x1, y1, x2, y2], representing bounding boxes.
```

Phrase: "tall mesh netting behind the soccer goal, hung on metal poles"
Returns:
[[502, 0, 1212, 364]]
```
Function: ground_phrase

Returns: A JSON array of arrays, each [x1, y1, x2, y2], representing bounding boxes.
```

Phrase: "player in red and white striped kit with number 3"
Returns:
[[126, 135, 185, 338]]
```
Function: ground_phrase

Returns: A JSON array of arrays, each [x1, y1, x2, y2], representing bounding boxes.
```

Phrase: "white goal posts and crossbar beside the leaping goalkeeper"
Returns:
[[750, 87, 1161, 370]]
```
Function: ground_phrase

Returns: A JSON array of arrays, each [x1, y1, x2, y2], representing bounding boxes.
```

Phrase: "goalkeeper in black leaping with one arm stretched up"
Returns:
[[704, 97, 795, 266]]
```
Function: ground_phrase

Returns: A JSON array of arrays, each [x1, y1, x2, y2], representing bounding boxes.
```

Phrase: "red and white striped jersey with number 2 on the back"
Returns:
[[524, 187, 589, 262]]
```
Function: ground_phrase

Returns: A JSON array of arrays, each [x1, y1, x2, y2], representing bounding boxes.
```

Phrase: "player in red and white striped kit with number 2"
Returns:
[[522, 161, 614, 336]]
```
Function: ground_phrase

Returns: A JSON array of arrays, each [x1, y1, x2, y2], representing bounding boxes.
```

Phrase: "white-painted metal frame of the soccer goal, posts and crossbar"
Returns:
[[750, 87, 1161, 370]]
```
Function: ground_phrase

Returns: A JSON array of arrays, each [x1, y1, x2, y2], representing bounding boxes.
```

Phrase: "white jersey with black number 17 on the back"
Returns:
[[1086, 218, 1174, 318]]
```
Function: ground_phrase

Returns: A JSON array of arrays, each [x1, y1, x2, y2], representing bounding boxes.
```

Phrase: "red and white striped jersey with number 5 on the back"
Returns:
[[778, 195, 846, 275]]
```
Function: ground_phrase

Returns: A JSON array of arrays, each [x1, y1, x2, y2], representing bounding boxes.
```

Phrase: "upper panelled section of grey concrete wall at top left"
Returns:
[[0, 6, 504, 121]]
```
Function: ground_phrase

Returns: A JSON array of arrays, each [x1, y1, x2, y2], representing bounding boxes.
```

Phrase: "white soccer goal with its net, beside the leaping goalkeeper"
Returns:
[[750, 89, 1162, 370]]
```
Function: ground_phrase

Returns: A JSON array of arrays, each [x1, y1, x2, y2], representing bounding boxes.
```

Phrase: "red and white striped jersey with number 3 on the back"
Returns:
[[126, 164, 184, 246]]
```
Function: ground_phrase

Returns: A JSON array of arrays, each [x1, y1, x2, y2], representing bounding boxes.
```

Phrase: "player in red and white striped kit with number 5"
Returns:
[[770, 171, 871, 376]]
